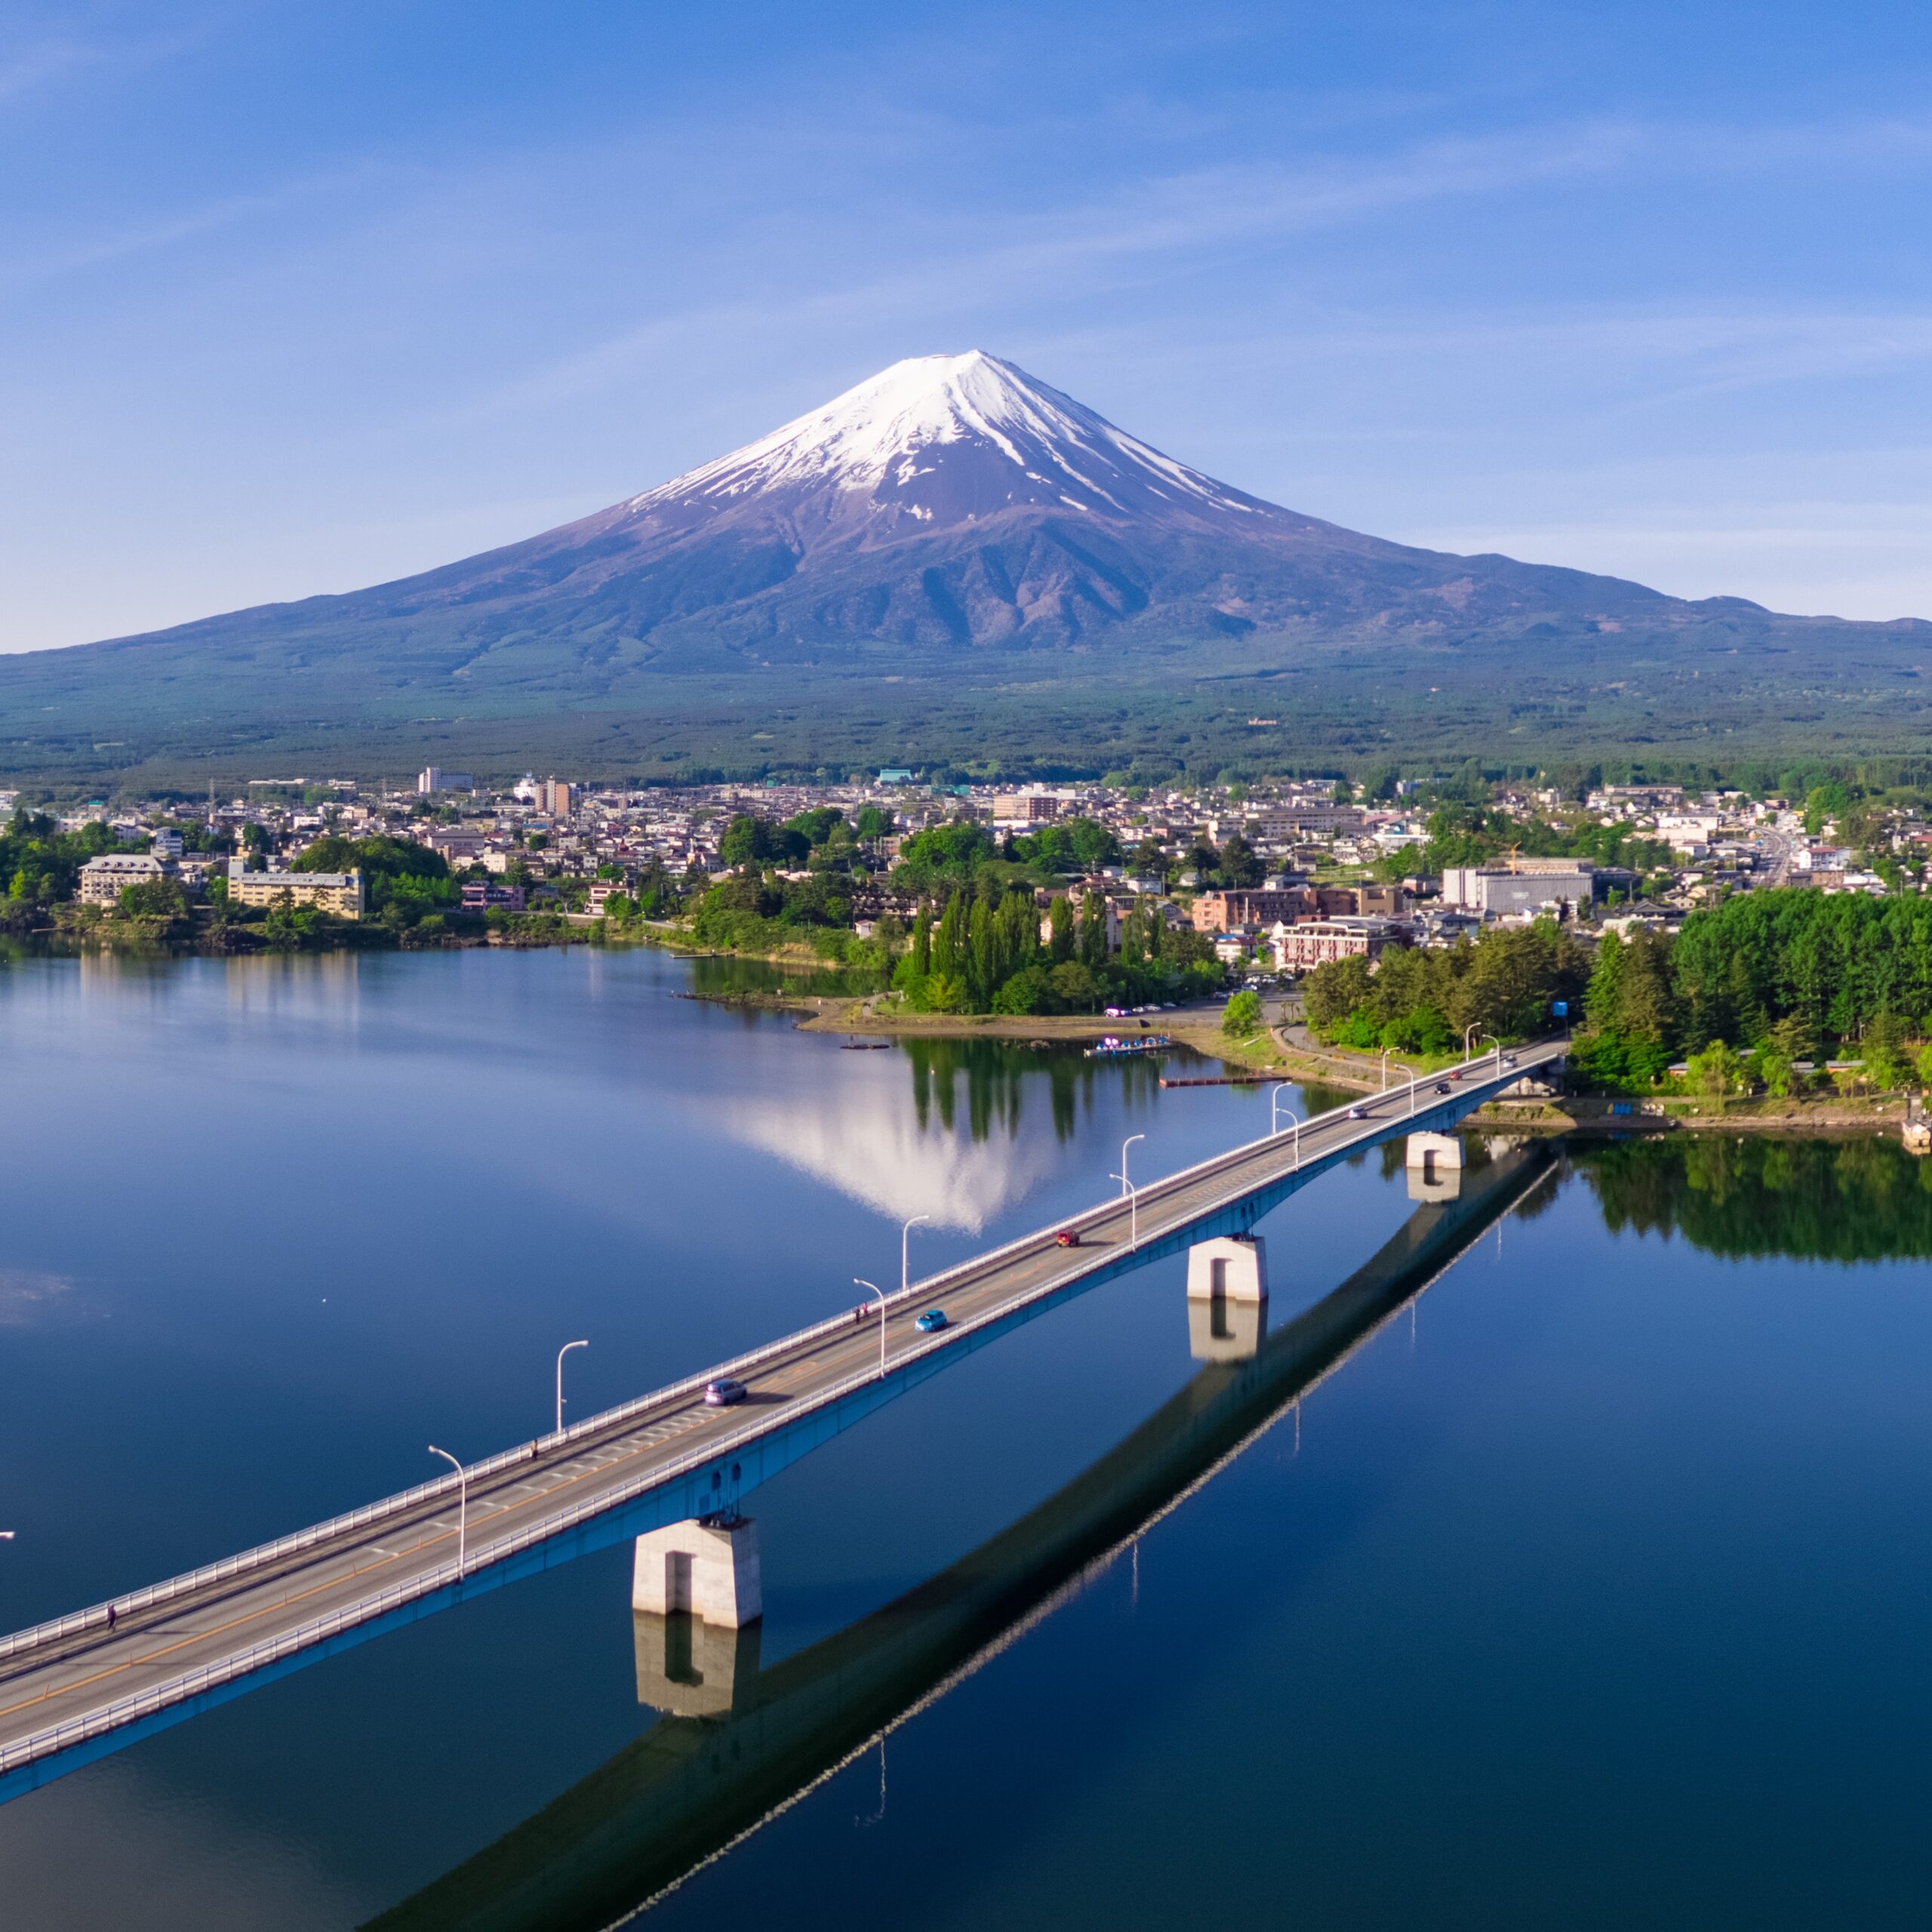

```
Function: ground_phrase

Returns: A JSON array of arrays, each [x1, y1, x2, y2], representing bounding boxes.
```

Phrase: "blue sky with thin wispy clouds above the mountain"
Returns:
[[0, 0, 1932, 649]]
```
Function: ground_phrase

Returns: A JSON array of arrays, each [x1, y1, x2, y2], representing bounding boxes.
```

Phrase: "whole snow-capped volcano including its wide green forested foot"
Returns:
[[0, 349, 1932, 777]]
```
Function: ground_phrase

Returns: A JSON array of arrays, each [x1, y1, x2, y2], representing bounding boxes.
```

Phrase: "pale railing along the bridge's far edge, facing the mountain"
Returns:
[[0, 1045, 1534, 1660]]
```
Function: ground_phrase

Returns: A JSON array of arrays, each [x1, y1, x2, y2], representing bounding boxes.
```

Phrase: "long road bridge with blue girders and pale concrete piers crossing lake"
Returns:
[[0, 1039, 1567, 1801]]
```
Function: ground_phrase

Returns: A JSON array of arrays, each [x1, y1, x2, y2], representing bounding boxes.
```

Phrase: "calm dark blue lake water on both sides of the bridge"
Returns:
[[0, 951, 1932, 1932]]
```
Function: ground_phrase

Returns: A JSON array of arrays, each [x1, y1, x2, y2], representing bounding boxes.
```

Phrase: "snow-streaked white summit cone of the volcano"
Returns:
[[624, 349, 1271, 531]]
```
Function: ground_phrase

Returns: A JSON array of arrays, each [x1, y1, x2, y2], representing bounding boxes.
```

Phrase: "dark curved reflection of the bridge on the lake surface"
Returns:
[[369, 1142, 1555, 1932]]
